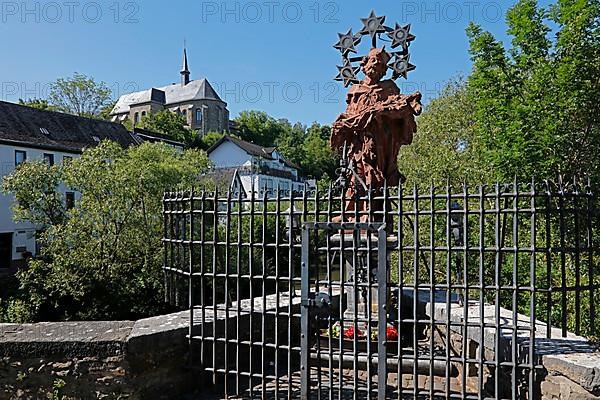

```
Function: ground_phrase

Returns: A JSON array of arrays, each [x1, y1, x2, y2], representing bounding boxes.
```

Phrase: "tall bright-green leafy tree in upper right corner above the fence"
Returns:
[[467, 0, 600, 180]]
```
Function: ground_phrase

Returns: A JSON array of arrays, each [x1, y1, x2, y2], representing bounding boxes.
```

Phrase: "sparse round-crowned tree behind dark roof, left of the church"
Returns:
[[48, 72, 111, 117]]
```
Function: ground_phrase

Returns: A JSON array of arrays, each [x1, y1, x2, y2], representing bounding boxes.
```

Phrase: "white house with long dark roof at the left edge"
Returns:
[[0, 101, 183, 274]]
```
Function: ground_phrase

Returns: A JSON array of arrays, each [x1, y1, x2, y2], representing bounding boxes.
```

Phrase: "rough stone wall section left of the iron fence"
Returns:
[[0, 312, 194, 399]]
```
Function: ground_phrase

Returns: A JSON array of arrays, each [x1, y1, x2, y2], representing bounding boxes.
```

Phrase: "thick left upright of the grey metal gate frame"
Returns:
[[300, 225, 310, 400]]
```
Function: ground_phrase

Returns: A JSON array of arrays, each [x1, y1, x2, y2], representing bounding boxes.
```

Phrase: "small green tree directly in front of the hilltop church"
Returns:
[[141, 110, 202, 148]]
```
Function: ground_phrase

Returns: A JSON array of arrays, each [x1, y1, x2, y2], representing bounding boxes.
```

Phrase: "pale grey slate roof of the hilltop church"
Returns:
[[111, 79, 223, 115]]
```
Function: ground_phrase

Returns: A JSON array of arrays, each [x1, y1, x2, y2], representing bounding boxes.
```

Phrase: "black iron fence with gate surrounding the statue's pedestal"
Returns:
[[164, 181, 600, 399]]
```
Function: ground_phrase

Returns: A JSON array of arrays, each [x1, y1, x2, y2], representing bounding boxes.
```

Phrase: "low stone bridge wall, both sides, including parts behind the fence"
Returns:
[[0, 295, 600, 400]]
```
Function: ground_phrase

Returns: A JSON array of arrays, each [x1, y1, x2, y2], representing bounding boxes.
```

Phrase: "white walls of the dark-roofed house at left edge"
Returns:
[[0, 144, 79, 261]]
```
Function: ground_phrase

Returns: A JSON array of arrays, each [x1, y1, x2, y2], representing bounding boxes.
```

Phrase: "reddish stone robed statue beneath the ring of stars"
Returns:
[[330, 48, 422, 221]]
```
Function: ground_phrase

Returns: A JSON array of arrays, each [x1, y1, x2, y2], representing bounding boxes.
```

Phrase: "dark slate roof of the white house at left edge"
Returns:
[[0, 101, 139, 153]]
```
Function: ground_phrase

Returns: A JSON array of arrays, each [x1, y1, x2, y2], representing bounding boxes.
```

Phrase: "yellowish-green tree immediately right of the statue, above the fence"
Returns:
[[398, 78, 492, 187]]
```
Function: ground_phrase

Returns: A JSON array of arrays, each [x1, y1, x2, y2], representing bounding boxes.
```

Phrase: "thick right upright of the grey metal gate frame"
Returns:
[[380, 223, 387, 400]]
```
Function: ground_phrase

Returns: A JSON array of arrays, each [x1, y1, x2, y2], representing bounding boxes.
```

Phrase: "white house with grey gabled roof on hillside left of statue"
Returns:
[[207, 135, 304, 196]]
